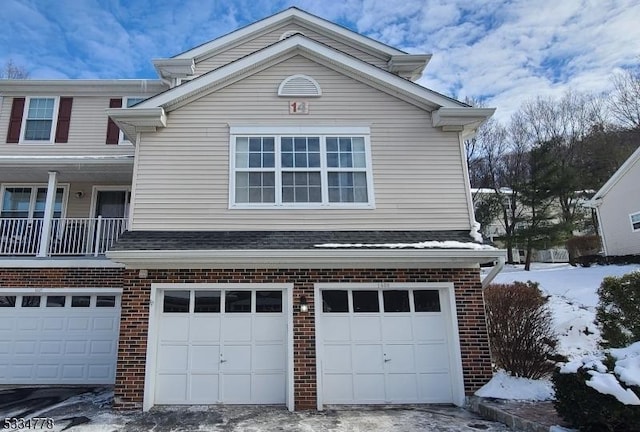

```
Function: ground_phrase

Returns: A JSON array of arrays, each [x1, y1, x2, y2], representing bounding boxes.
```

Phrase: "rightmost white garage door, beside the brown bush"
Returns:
[[319, 288, 454, 404]]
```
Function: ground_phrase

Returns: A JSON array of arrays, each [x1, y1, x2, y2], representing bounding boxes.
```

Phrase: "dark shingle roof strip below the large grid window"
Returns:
[[112, 231, 472, 251]]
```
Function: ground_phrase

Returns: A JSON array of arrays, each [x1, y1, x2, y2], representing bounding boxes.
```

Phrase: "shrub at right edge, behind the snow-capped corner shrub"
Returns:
[[596, 272, 640, 347]]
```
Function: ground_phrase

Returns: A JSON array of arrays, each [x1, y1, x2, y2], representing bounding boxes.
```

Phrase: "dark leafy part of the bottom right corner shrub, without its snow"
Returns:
[[551, 359, 640, 432]]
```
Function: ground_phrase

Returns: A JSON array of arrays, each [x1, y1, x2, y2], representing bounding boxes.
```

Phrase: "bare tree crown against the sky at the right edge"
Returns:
[[609, 66, 640, 130]]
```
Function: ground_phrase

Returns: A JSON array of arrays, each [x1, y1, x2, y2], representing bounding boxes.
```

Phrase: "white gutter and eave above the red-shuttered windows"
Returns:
[[0, 79, 169, 97]]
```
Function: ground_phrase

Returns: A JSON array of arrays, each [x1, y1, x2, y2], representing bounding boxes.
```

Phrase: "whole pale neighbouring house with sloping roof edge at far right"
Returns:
[[586, 148, 640, 256]]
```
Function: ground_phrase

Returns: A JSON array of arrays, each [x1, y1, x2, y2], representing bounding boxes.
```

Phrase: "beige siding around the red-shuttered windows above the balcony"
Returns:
[[0, 95, 134, 156]]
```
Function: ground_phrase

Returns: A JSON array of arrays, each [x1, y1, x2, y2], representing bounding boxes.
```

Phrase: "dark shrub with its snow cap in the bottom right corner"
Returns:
[[552, 342, 640, 432]]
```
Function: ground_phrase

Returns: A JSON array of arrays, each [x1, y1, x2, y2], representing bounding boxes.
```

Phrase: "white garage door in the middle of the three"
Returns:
[[154, 289, 286, 404]]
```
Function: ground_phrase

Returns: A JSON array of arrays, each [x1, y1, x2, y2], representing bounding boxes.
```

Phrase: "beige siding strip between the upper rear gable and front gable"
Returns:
[[196, 23, 388, 75]]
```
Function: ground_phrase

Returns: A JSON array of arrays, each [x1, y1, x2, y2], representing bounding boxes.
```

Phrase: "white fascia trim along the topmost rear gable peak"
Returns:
[[173, 8, 406, 59]]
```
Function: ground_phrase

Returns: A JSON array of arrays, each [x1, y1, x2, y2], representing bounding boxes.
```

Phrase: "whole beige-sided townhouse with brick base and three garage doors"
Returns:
[[0, 8, 504, 409]]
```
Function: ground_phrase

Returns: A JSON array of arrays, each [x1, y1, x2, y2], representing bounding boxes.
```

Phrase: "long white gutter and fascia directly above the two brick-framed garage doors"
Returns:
[[106, 248, 506, 269]]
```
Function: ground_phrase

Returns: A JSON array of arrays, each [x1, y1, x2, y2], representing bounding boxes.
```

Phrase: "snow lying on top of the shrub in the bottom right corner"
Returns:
[[560, 342, 640, 405]]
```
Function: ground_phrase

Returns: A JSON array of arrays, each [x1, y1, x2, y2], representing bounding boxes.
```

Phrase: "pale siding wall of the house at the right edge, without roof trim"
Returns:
[[599, 161, 640, 255]]
